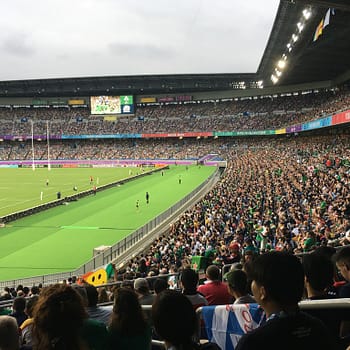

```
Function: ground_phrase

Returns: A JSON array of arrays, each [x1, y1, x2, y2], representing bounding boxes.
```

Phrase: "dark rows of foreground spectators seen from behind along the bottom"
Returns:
[[0, 246, 350, 350]]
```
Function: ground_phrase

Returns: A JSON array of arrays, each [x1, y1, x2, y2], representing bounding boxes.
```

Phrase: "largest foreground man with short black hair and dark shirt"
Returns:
[[236, 252, 335, 350]]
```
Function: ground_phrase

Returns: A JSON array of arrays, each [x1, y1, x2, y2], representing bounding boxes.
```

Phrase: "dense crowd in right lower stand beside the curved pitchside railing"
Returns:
[[115, 135, 350, 274]]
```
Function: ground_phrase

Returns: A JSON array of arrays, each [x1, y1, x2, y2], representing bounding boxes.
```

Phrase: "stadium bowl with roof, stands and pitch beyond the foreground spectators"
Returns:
[[0, 0, 350, 349]]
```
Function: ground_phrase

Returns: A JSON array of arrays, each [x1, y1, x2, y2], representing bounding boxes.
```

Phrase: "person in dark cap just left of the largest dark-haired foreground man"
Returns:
[[224, 269, 256, 304]]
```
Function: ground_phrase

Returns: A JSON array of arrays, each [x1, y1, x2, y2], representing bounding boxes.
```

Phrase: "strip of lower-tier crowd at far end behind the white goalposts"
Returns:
[[0, 139, 227, 160]]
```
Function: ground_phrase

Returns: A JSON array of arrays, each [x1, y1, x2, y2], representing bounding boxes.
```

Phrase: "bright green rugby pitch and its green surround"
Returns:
[[0, 166, 215, 281]]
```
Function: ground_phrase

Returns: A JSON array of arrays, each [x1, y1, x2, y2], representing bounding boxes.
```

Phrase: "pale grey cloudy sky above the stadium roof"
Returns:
[[0, 0, 279, 81]]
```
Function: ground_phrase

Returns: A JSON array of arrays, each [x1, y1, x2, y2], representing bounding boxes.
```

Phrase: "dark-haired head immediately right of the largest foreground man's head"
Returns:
[[303, 253, 334, 297]]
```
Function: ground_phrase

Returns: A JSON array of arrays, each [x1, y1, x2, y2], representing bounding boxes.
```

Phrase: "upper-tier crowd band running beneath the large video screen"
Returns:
[[0, 90, 350, 136]]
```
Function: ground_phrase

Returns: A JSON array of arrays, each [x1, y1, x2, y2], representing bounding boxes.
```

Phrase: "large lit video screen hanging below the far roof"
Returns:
[[90, 95, 134, 114]]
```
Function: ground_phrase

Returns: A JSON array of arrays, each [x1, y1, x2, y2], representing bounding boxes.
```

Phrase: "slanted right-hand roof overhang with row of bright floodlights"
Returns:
[[257, 0, 350, 86]]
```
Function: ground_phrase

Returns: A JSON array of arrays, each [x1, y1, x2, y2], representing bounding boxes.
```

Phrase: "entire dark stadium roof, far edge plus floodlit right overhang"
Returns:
[[0, 0, 350, 97]]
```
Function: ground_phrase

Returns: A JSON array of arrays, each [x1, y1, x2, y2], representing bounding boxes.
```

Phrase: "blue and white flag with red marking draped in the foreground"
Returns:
[[202, 304, 265, 350]]
